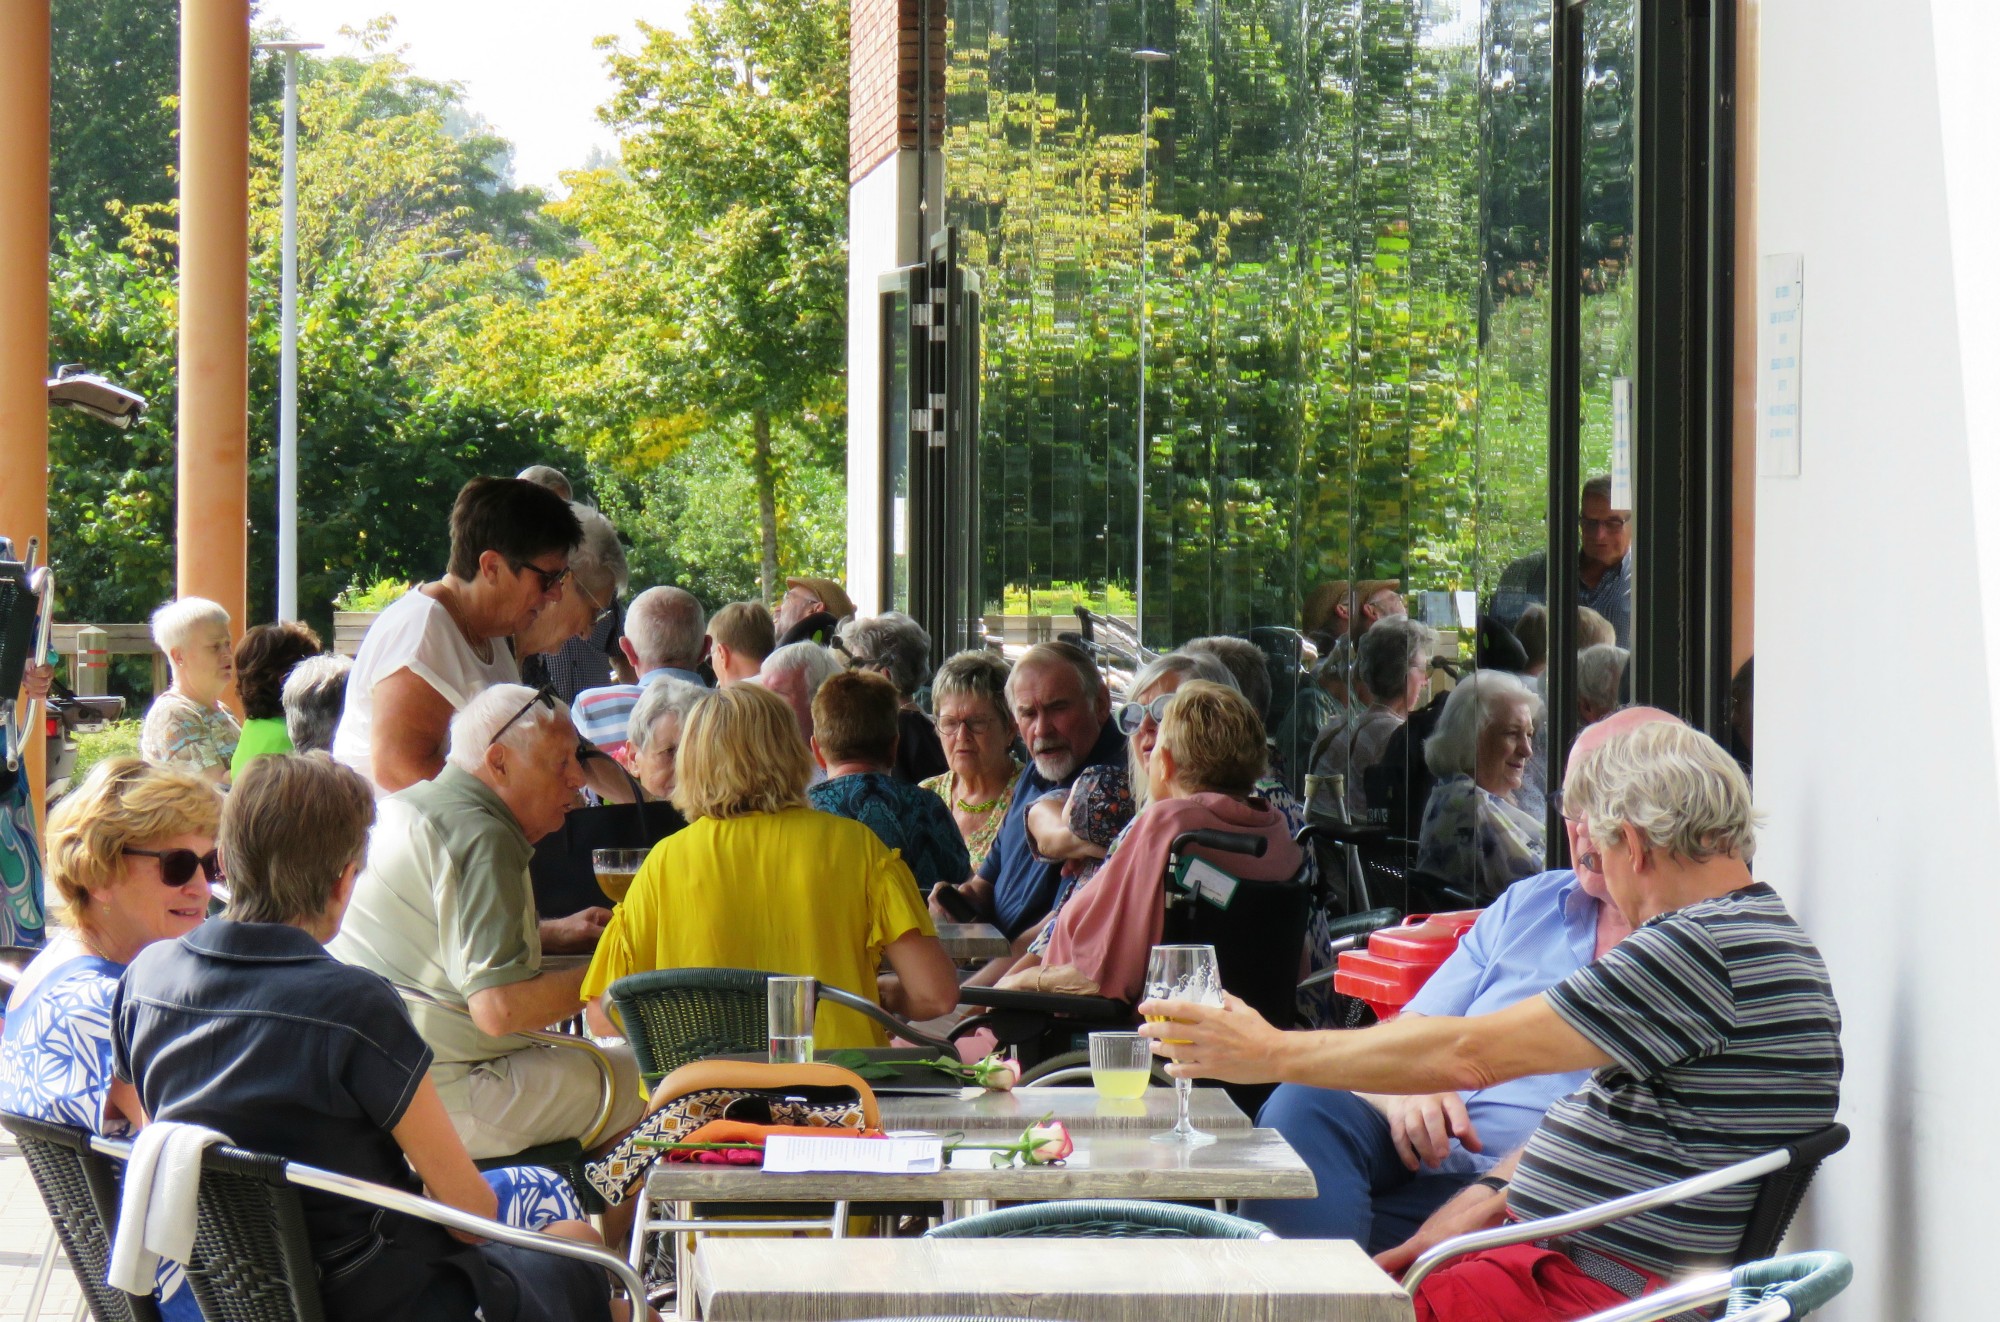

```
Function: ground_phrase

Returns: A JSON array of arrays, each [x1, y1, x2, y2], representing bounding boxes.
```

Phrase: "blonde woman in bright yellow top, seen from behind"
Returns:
[[584, 684, 958, 1048]]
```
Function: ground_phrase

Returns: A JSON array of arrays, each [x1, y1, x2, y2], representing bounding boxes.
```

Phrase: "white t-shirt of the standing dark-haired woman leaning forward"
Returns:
[[334, 592, 520, 794]]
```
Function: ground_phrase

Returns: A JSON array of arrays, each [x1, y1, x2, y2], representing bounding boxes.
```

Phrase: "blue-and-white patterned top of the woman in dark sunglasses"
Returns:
[[0, 932, 202, 1322]]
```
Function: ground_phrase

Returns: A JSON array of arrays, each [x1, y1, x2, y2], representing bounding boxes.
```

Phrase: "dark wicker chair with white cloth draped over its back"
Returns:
[[6, 1116, 642, 1322]]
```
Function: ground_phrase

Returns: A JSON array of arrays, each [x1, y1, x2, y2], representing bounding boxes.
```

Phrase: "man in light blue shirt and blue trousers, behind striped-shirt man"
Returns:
[[1244, 708, 1680, 1252]]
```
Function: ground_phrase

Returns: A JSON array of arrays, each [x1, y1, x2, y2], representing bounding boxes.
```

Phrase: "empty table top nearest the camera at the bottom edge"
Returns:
[[694, 1238, 1412, 1322]]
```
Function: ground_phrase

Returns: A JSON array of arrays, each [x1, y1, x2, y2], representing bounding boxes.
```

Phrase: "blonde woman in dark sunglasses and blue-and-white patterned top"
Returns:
[[0, 758, 222, 1322]]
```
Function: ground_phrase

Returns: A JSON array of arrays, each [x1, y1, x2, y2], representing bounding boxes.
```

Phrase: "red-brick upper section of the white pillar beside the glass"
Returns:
[[848, 0, 946, 182]]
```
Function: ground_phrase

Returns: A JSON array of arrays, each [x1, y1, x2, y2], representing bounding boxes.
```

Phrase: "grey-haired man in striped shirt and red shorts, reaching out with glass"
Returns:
[[1140, 722, 1842, 1322]]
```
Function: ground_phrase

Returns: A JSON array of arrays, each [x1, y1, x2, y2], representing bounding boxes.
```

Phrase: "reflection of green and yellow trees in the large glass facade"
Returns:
[[944, 0, 1630, 642]]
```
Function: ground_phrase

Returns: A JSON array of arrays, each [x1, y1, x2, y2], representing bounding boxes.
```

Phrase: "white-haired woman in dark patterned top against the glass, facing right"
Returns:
[[1416, 670, 1544, 902]]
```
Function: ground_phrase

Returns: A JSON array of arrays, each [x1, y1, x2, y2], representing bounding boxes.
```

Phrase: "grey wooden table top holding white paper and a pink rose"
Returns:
[[646, 1130, 1318, 1202]]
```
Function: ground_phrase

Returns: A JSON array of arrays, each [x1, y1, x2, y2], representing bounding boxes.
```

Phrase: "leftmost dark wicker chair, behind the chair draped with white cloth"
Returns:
[[0, 1112, 160, 1322]]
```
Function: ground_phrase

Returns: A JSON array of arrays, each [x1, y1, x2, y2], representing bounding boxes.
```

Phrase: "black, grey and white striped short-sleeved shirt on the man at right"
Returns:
[[1508, 882, 1840, 1274]]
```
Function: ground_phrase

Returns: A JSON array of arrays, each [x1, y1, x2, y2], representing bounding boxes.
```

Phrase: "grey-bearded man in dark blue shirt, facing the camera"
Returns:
[[960, 642, 1126, 940]]
